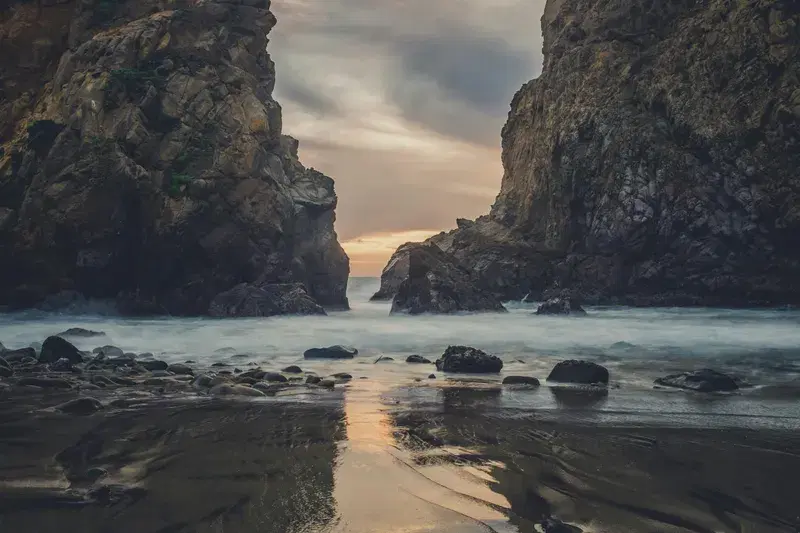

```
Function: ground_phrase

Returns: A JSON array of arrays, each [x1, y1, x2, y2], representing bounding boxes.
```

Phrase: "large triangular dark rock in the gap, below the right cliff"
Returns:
[[391, 244, 506, 315]]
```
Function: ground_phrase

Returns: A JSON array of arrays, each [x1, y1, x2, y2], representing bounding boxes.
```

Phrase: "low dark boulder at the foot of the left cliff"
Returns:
[[208, 283, 326, 318]]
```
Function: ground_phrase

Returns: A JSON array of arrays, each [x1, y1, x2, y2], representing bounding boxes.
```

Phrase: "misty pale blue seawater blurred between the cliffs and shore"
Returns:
[[0, 278, 800, 427]]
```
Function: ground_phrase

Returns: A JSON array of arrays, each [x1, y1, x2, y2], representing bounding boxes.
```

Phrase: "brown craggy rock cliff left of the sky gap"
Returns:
[[0, 0, 349, 314]]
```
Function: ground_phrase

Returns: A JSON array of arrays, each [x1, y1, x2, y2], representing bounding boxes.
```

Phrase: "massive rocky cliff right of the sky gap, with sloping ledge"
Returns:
[[376, 0, 800, 305]]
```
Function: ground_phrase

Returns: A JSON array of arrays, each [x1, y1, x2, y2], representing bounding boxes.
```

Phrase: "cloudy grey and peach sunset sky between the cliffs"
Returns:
[[269, 0, 544, 276]]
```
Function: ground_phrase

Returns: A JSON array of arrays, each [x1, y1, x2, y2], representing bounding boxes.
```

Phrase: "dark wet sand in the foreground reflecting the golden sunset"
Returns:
[[0, 379, 800, 533]]
